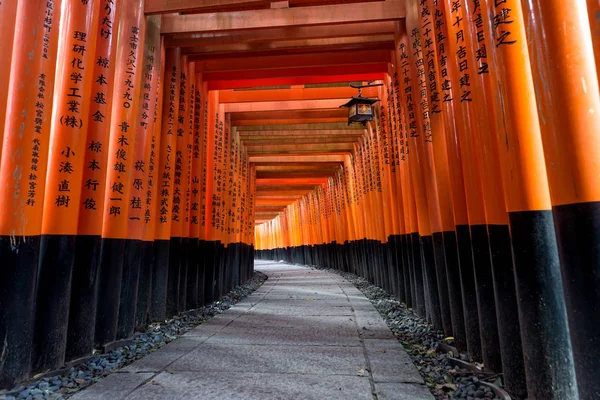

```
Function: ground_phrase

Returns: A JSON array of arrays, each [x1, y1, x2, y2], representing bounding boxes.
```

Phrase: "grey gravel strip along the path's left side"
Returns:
[[0, 271, 267, 400]]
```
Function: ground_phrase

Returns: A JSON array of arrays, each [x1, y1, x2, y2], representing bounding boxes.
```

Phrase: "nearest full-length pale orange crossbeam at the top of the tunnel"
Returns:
[[161, 0, 406, 34]]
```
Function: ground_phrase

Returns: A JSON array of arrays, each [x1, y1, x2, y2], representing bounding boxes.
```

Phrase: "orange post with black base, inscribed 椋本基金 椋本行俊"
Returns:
[[66, 0, 121, 360]]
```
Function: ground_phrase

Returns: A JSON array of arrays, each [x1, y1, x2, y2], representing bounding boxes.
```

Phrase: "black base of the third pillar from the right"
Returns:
[[487, 225, 527, 398]]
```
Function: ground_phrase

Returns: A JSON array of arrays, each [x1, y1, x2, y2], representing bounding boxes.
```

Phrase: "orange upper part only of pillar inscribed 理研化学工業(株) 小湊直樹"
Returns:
[[43, 0, 99, 238]]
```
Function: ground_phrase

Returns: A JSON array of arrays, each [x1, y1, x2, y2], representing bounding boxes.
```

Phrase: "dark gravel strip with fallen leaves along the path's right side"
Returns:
[[309, 266, 516, 400]]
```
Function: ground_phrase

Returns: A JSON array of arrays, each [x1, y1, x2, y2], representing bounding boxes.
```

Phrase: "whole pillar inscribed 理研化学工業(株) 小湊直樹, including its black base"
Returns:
[[33, 0, 100, 372]]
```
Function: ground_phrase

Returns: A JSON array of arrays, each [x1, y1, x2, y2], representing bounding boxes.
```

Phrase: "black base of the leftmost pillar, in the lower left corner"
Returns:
[[0, 236, 40, 389]]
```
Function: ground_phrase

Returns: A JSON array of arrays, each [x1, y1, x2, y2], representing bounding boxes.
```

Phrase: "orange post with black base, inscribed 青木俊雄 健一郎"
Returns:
[[94, 0, 145, 345]]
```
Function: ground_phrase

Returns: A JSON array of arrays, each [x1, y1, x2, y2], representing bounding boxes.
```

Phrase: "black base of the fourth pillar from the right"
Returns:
[[471, 225, 502, 372]]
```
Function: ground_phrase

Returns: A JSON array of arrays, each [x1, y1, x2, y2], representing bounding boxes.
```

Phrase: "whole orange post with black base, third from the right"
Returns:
[[461, 0, 527, 397]]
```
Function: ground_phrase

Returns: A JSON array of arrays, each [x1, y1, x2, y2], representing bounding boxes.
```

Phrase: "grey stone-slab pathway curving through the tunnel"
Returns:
[[72, 261, 433, 400]]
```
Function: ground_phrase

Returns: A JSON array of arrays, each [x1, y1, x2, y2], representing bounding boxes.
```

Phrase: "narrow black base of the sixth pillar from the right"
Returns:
[[443, 231, 467, 350]]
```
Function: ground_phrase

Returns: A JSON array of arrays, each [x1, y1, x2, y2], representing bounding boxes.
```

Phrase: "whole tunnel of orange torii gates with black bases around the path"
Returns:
[[0, 0, 600, 400]]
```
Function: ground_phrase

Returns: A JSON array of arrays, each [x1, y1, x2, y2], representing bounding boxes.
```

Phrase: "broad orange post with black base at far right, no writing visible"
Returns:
[[524, 0, 600, 399]]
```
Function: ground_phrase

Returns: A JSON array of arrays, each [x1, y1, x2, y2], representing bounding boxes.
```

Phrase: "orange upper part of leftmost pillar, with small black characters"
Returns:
[[0, 0, 60, 236]]
